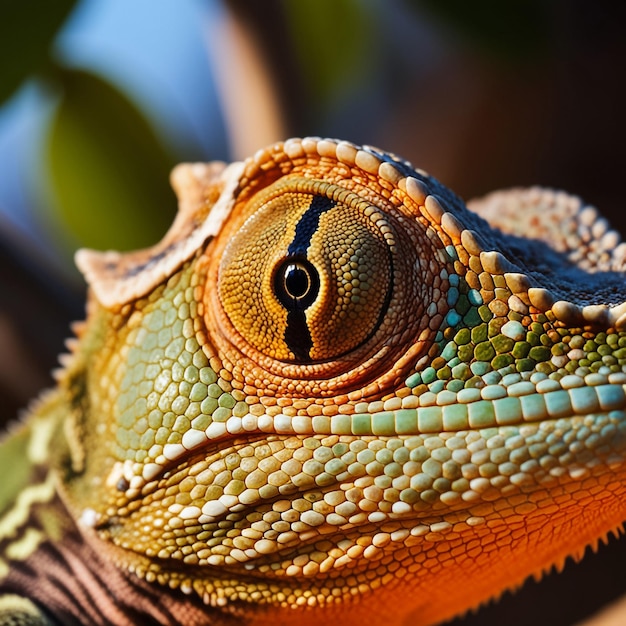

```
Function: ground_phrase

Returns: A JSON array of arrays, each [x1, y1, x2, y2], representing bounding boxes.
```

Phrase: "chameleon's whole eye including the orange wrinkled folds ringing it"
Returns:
[[202, 166, 448, 397]]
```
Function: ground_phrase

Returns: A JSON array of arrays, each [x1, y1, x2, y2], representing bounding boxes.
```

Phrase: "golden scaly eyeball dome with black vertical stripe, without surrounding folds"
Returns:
[[212, 179, 394, 364]]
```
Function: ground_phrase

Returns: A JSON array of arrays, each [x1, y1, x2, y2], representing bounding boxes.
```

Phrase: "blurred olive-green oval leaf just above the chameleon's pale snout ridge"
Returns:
[[47, 69, 176, 250]]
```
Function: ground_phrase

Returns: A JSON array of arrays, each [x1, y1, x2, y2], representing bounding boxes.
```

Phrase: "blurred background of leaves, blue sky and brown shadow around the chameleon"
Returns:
[[0, 0, 626, 626]]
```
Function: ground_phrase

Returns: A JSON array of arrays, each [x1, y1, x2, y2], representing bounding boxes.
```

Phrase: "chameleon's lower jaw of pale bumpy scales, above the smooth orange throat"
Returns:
[[83, 404, 626, 599]]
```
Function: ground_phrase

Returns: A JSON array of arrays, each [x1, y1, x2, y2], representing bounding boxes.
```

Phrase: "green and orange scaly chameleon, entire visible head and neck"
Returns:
[[0, 137, 626, 626]]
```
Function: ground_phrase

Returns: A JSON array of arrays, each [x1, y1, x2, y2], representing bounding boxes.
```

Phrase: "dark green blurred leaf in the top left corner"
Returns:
[[0, 0, 76, 103]]
